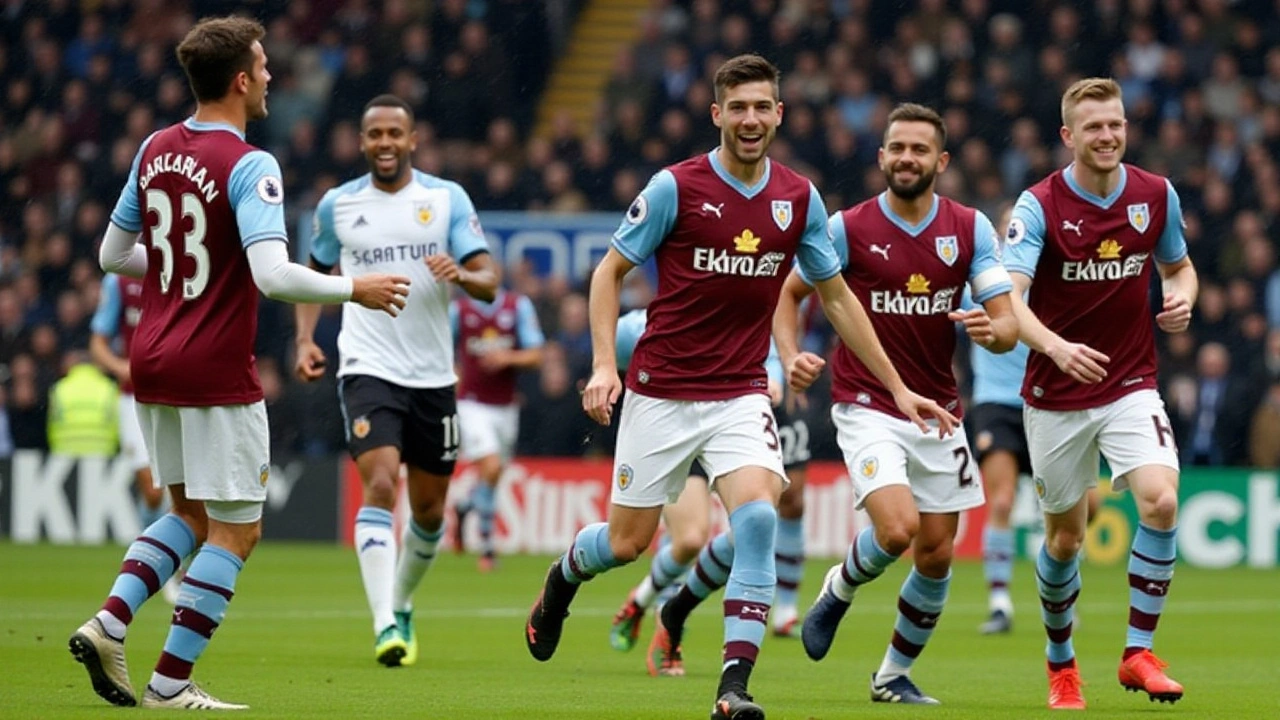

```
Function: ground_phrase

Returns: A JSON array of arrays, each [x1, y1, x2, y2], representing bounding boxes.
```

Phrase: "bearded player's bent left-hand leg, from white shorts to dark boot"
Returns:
[[800, 404, 919, 660]]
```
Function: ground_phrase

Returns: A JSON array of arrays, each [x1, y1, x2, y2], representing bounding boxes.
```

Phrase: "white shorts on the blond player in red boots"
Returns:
[[1023, 389, 1179, 514]]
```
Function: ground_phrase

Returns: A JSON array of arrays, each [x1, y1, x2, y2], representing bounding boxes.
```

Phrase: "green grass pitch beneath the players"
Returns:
[[0, 543, 1280, 720]]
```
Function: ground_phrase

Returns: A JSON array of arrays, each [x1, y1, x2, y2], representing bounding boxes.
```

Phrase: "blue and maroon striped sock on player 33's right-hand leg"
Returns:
[[151, 543, 244, 697]]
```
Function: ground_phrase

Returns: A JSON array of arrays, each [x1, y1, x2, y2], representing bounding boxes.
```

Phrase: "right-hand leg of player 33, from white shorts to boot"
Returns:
[[142, 401, 270, 710]]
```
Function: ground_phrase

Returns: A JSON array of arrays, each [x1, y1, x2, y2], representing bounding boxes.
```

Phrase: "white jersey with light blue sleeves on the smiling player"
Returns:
[[311, 170, 489, 388]]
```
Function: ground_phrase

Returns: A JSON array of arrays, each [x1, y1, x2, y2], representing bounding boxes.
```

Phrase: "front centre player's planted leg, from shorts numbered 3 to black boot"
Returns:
[[700, 395, 786, 719]]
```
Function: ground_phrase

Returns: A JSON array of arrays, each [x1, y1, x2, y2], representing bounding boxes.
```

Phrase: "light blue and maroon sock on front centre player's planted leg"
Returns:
[[724, 500, 778, 667]]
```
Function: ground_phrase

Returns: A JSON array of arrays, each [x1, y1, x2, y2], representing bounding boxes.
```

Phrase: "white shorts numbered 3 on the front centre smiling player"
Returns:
[[612, 391, 787, 507]]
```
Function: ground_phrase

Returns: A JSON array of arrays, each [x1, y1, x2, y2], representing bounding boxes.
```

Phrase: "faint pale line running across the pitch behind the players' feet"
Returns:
[[0, 598, 1280, 625]]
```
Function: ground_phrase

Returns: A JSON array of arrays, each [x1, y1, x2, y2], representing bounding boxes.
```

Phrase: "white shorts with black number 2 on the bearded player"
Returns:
[[831, 402, 987, 512]]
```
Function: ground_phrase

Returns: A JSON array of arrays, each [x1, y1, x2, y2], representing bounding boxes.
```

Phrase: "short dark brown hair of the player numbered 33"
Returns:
[[177, 15, 266, 102]]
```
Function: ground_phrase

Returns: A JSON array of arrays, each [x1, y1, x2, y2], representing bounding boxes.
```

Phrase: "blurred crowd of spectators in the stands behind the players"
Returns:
[[0, 0, 1280, 468]]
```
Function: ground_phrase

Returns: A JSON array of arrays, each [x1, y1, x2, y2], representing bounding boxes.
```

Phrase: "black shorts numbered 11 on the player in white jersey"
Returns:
[[338, 375, 458, 475]]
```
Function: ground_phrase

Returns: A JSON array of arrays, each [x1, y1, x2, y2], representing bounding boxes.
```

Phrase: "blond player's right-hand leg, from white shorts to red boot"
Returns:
[[1098, 391, 1183, 702]]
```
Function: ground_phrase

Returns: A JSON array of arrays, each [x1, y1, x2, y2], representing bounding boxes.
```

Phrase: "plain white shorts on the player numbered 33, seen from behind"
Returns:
[[138, 401, 271, 502]]
